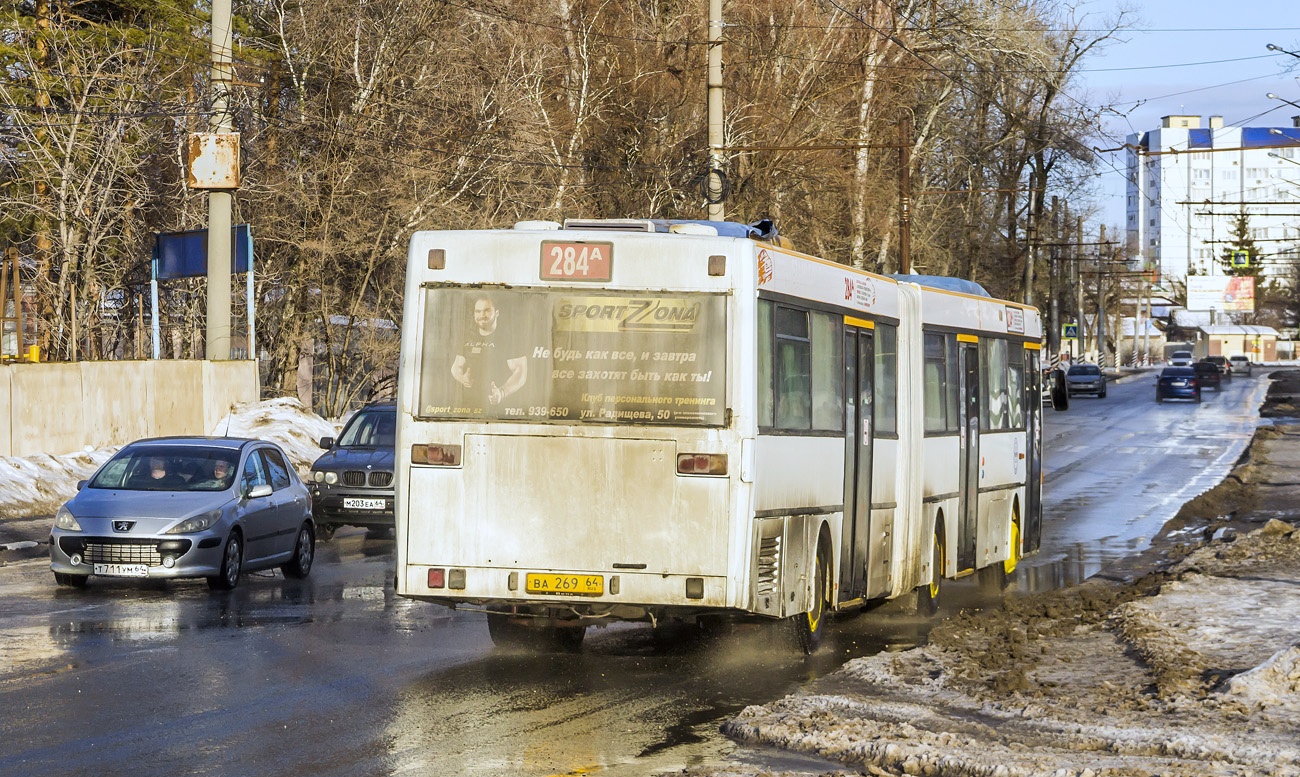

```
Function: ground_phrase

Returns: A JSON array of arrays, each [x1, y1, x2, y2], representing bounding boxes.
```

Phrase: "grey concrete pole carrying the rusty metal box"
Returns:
[[204, 0, 234, 360]]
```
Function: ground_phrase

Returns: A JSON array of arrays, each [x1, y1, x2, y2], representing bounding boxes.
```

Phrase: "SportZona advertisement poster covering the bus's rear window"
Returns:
[[419, 287, 727, 426]]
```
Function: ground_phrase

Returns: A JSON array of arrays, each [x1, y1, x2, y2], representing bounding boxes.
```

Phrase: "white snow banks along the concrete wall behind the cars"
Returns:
[[0, 398, 338, 520]]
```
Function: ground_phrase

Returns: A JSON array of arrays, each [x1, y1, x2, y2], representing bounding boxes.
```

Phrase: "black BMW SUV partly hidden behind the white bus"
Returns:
[[307, 403, 398, 541]]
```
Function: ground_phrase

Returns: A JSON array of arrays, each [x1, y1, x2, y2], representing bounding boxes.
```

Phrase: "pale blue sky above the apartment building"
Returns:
[[1071, 0, 1300, 229]]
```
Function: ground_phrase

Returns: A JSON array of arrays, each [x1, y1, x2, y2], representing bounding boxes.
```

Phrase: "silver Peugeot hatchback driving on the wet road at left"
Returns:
[[49, 437, 316, 590]]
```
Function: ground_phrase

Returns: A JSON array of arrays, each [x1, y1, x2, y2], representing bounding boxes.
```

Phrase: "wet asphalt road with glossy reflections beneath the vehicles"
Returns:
[[0, 374, 1266, 776]]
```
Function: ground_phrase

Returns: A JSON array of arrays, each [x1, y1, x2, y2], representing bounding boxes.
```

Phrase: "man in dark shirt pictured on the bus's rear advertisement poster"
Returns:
[[451, 295, 528, 408]]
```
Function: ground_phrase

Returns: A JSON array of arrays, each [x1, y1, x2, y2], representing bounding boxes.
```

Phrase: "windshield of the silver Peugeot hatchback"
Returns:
[[88, 446, 239, 491]]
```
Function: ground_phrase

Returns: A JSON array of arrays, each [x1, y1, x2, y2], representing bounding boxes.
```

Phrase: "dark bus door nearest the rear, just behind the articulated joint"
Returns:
[[840, 320, 875, 602]]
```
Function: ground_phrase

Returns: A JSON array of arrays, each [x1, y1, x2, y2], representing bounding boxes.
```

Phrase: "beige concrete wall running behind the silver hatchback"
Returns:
[[0, 360, 260, 456]]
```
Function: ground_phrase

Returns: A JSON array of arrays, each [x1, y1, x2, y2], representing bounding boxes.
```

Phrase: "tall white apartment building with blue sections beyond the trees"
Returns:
[[1126, 116, 1300, 281]]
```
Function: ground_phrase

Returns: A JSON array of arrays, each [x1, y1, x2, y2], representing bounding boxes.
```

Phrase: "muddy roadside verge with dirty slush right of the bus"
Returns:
[[684, 370, 1300, 777]]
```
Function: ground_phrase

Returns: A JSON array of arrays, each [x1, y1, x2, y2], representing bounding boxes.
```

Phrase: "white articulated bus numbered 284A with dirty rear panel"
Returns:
[[395, 220, 1043, 650]]
